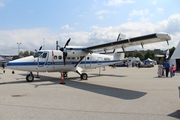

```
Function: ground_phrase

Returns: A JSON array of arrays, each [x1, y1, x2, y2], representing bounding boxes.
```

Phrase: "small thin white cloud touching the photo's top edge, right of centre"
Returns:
[[104, 0, 134, 6]]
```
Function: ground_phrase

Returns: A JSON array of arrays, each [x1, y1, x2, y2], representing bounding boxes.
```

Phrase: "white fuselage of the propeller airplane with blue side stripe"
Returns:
[[7, 50, 120, 72]]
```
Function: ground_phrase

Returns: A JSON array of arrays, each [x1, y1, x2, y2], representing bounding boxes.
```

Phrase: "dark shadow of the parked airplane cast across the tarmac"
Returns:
[[0, 74, 147, 100]]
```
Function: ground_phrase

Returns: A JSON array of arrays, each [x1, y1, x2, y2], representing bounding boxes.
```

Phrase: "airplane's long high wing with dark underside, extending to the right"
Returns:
[[86, 33, 171, 52]]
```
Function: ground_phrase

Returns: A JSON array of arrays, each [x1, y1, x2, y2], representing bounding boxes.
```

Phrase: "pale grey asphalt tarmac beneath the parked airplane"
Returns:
[[0, 66, 180, 120]]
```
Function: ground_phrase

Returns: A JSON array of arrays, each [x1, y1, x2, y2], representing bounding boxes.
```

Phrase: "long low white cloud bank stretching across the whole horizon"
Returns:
[[0, 14, 180, 54]]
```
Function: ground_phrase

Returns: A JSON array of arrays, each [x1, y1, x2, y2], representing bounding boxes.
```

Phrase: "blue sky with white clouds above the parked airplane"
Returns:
[[0, 0, 180, 55]]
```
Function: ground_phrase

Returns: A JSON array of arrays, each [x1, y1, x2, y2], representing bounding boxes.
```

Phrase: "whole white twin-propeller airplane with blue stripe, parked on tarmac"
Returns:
[[7, 33, 171, 82]]
